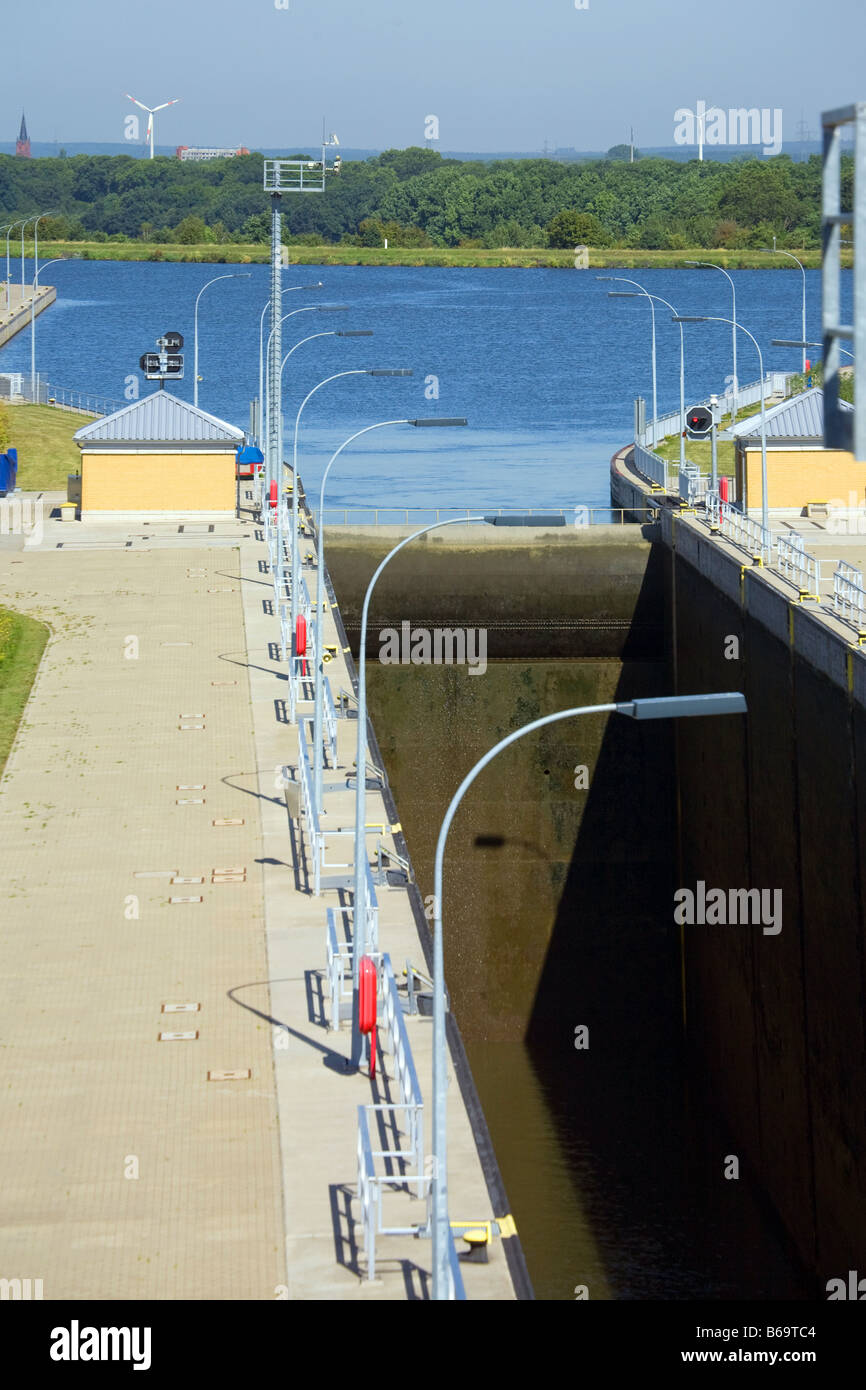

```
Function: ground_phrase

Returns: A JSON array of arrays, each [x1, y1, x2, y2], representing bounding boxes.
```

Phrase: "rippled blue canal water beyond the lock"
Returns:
[[0, 261, 851, 507]]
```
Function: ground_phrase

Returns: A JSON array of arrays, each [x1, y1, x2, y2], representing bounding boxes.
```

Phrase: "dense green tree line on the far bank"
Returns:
[[0, 149, 853, 250]]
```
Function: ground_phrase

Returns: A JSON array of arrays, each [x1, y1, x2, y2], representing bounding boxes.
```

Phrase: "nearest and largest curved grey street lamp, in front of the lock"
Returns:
[[430, 694, 746, 1300]]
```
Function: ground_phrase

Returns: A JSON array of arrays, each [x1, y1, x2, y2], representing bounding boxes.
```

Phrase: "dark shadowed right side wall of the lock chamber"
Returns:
[[671, 542, 866, 1287]]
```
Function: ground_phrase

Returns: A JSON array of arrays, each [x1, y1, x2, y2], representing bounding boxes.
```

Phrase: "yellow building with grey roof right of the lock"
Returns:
[[719, 386, 866, 512]]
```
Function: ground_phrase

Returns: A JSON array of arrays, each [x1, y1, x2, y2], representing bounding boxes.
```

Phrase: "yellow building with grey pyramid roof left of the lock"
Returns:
[[74, 391, 243, 521]]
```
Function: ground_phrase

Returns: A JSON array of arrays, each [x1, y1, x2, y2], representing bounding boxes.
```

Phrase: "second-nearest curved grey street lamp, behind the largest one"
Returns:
[[348, 508, 566, 1065]]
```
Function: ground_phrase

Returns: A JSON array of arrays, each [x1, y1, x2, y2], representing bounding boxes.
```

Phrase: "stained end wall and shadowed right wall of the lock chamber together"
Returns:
[[327, 524, 866, 1289]]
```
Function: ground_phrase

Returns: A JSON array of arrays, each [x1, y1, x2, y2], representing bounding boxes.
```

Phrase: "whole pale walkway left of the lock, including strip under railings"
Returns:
[[0, 503, 514, 1301]]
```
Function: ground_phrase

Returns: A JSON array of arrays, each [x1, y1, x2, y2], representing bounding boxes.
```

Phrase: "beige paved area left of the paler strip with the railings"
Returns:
[[0, 527, 285, 1300]]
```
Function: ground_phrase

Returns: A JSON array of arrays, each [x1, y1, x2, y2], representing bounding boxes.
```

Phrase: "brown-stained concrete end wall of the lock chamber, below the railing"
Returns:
[[325, 527, 678, 1047]]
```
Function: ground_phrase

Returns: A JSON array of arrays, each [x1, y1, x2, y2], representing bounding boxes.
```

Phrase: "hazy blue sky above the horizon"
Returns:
[[0, 0, 866, 150]]
